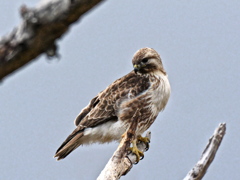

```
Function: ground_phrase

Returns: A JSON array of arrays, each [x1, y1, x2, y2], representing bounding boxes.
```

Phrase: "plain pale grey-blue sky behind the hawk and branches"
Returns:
[[0, 0, 240, 180]]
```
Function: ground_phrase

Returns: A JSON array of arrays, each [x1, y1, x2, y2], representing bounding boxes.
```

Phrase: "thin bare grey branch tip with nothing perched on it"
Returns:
[[184, 123, 226, 180]]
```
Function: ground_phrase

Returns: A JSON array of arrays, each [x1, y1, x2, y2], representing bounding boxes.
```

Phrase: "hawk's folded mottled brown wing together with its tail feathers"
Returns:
[[55, 71, 150, 160]]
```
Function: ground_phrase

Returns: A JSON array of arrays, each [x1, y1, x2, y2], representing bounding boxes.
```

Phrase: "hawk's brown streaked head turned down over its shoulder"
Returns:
[[132, 48, 166, 74]]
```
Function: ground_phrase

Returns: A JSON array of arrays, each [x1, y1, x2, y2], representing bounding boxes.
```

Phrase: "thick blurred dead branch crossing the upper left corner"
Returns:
[[0, 0, 103, 80]]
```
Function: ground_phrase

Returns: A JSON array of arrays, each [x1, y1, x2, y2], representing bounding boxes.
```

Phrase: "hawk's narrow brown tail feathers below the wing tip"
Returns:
[[54, 126, 84, 160]]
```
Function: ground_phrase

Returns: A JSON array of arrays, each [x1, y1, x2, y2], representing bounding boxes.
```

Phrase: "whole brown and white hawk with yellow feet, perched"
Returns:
[[54, 48, 170, 161]]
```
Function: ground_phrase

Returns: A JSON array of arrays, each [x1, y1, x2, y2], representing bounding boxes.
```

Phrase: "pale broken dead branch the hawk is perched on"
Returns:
[[97, 109, 151, 180]]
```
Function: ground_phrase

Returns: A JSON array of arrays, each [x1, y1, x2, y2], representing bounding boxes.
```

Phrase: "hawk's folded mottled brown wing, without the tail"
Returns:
[[75, 71, 150, 127]]
